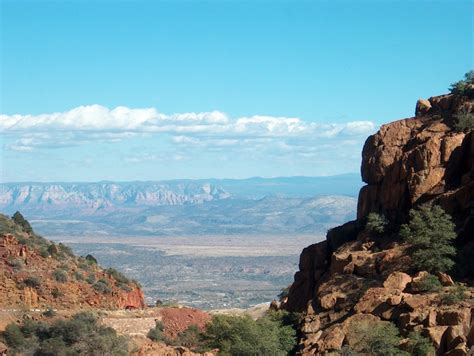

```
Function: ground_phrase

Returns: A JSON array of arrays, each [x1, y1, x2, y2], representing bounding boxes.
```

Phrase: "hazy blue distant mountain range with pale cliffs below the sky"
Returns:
[[0, 174, 362, 236]]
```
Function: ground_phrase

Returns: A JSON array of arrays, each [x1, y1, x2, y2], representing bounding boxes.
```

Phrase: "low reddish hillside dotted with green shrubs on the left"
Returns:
[[0, 214, 144, 310]]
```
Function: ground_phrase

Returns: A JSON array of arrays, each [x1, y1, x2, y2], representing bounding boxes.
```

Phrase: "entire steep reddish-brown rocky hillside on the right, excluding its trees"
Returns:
[[282, 88, 474, 355]]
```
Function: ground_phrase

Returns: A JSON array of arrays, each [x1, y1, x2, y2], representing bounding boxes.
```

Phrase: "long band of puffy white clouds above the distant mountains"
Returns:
[[0, 105, 375, 151]]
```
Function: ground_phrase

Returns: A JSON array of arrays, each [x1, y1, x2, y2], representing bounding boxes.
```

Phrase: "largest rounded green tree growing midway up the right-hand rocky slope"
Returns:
[[400, 205, 456, 273]]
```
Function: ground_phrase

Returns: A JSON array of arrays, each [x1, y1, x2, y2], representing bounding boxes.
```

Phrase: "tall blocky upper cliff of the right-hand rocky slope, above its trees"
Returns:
[[357, 95, 474, 236]]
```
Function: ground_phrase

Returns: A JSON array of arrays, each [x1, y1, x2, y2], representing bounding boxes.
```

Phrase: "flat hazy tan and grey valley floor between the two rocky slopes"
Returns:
[[53, 235, 322, 310]]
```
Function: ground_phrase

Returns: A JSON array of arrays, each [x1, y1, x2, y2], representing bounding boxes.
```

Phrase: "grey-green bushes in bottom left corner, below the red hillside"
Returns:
[[2, 313, 128, 356]]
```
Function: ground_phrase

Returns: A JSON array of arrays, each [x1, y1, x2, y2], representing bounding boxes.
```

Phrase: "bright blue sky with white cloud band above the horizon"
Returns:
[[0, 0, 474, 182]]
